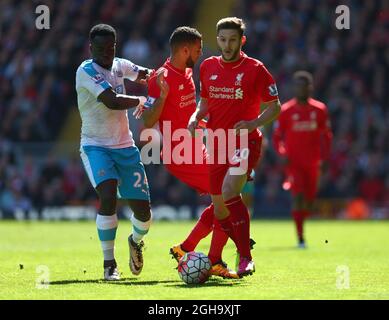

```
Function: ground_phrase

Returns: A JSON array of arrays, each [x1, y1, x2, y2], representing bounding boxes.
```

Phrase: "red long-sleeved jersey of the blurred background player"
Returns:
[[273, 98, 332, 165]]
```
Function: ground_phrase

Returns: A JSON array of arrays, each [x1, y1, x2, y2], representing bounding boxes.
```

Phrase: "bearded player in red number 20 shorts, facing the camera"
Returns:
[[188, 17, 280, 277]]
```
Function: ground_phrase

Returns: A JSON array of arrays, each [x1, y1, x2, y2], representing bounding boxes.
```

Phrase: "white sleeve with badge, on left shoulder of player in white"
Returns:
[[76, 67, 112, 98]]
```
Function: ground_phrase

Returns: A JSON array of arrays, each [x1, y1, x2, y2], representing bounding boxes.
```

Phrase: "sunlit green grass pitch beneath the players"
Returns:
[[0, 220, 389, 300]]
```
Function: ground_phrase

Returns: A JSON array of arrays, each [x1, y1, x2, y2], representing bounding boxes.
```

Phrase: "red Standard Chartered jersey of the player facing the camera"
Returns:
[[200, 52, 278, 138]]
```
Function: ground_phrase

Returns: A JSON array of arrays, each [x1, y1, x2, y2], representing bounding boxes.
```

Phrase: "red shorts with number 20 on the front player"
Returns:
[[208, 135, 262, 195]]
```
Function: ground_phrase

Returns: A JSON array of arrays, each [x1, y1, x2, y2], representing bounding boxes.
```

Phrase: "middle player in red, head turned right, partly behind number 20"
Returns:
[[135, 27, 238, 278]]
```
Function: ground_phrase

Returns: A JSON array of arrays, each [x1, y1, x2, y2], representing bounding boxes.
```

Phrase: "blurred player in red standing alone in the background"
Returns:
[[273, 71, 332, 248]]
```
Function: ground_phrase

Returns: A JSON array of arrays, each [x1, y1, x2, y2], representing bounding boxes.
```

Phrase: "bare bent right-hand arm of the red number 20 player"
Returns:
[[234, 99, 281, 135]]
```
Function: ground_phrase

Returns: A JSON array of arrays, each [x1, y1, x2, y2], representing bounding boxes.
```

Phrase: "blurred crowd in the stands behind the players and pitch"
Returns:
[[0, 0, 389, 218]]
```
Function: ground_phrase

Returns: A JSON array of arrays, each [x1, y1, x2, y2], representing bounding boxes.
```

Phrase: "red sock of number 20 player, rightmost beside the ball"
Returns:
[[224, 196, 252, 260]]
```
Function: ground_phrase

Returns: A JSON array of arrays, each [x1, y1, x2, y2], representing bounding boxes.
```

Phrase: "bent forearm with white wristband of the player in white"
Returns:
[[97, 88, 146, 110]]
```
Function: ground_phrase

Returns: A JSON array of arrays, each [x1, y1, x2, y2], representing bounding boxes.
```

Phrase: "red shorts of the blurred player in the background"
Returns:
[[284, 164, 320, 201]]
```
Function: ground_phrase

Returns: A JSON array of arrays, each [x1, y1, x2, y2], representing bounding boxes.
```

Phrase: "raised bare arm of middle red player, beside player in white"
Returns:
[[142, 69, 169, 128]]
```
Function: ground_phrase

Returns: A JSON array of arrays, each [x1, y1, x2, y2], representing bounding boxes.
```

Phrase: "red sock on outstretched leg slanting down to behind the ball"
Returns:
[[181, 204, 214, 252]]
